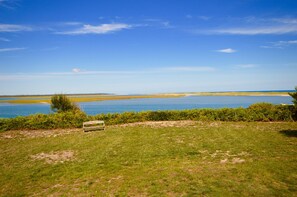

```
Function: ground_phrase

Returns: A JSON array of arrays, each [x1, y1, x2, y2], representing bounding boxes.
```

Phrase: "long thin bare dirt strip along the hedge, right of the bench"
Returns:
[[114, 120, 196, 128]]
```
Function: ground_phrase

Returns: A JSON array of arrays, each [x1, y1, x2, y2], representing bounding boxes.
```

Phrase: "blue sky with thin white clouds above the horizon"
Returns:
[[0, 0, 297, 95]]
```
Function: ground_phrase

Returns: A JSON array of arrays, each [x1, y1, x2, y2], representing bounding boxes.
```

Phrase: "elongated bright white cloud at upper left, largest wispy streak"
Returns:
[[57, 23, 132, 35]]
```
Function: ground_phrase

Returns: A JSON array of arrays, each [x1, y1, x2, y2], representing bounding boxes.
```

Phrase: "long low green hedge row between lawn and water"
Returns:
[[0, 103, 294, 131]]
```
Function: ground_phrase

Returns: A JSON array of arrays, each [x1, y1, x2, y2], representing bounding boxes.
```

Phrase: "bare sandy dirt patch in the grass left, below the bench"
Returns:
[[31, 150, 74, 164]]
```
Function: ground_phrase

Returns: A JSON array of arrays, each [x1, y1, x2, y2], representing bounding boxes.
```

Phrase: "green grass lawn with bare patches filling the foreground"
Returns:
[[0, 122, 297, 196]]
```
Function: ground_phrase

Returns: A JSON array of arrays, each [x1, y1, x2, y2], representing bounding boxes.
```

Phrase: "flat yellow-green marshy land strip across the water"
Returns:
[[0, 90, 294, 104]]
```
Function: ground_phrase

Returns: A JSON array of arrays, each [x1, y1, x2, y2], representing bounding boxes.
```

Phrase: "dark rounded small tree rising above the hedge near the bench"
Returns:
[[51, 94, 80, 113]]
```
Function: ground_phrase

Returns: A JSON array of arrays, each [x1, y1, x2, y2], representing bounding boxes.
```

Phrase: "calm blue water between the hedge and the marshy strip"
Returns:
[[0, 96, 292, 118]]
